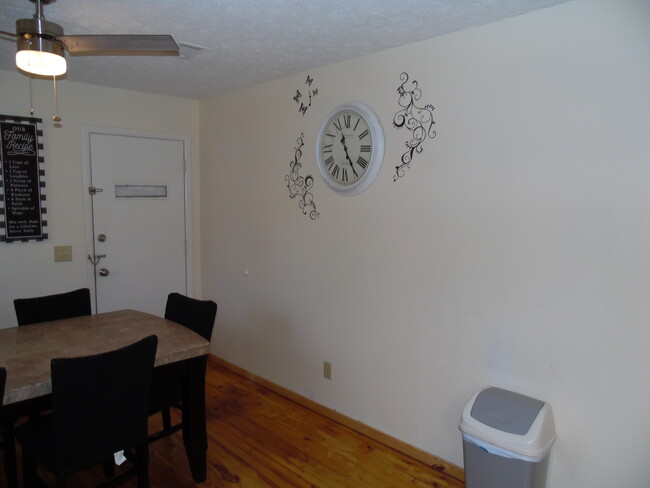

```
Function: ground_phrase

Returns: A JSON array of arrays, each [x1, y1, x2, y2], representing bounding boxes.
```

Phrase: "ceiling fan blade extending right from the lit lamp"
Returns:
[[56, 34, 179, 56]]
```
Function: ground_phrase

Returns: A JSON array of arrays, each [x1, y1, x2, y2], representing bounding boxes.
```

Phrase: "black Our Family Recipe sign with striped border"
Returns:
[[0, 115, 47, 242]]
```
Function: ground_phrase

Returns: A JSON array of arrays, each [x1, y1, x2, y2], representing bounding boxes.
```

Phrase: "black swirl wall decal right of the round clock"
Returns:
[[393, 73, 436, 181]]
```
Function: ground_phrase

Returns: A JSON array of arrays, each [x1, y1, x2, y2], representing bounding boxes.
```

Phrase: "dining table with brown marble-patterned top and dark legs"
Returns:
[[0, 310, 210, 485]]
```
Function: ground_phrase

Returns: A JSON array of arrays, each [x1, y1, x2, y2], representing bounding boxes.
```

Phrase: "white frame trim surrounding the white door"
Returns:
[[81, 125, 194, 311]]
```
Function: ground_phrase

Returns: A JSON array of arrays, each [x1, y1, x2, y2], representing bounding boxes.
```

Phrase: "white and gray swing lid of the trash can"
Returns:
[[458, 386, 555, 458]]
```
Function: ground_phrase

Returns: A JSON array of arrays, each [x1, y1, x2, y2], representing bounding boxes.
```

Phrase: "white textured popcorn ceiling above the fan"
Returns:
[[0, 0, 568, 98]]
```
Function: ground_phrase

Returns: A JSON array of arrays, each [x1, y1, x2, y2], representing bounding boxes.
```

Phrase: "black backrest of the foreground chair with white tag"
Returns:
[[51, 335, 158, 472]]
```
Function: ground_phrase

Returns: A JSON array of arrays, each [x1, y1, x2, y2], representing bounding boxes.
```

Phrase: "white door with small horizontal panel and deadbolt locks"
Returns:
[[86, 131, 189, 315]]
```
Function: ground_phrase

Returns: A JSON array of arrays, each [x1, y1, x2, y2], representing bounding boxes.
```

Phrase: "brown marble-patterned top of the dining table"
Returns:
[[0, 310, 210, 405]]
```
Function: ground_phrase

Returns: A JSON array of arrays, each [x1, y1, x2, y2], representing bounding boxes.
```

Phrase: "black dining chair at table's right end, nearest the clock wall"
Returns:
[[149, 293, 217, 441]]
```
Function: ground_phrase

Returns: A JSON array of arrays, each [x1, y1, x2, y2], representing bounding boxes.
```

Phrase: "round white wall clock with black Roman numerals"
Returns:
[[316, 102, 384, 195]]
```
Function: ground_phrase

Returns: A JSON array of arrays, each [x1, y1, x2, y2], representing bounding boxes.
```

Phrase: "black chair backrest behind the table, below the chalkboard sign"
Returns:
[[14, 288, 92, 325]]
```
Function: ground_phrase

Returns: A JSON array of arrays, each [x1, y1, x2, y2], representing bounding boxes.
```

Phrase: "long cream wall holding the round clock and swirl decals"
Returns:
[[200, 0, 650, 488]]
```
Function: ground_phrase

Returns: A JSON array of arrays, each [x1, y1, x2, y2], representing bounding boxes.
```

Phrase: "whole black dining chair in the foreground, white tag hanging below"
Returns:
[[16, 335, 158, 488]]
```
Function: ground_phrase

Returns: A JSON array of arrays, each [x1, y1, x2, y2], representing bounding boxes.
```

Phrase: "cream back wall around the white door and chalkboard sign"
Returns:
[[0, 71, 200, 327]]
